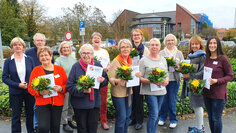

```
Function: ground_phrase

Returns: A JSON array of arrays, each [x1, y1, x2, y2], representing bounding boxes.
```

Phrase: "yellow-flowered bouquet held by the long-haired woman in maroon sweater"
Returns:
[[188, 79, 206, 94]]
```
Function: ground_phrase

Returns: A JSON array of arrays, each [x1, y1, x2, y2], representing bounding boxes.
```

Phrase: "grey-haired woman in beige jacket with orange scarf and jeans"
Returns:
[[109, 39, 141, 133]]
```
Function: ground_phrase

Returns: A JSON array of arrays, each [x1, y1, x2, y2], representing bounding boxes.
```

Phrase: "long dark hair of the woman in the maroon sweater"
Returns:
[[206, 36, 224, 59]]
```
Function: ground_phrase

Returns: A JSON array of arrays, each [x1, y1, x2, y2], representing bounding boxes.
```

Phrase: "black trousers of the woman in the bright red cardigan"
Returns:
[[36, 104, 63, 133]]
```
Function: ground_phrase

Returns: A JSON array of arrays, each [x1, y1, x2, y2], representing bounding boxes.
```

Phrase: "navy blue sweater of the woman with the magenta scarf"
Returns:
[[66, 61, 108, 109]]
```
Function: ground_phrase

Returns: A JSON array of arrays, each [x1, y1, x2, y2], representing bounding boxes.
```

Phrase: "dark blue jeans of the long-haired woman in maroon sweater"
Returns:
[[204, 97, 226, 133]]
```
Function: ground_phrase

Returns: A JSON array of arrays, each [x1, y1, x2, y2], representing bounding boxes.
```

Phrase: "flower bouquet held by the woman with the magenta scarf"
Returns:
[[76, 75, 95, 92]]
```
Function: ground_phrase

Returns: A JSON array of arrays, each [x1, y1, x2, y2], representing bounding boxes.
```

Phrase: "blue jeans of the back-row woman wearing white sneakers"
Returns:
[[160, 81, 180, 123]]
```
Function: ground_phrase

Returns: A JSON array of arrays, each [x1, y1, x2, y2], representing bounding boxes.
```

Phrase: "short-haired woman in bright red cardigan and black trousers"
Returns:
[[28, 46, 67, 133]]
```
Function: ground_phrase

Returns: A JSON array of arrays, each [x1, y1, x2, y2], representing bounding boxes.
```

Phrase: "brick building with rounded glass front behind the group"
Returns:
[[112, 4, 213, 40]]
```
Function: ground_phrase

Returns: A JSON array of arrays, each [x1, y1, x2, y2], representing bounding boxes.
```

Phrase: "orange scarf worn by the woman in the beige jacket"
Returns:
[[115, 54, 133, 106]]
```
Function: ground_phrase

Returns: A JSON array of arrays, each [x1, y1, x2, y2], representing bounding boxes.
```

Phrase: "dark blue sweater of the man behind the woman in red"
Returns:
[[25, 47, 54, 66]]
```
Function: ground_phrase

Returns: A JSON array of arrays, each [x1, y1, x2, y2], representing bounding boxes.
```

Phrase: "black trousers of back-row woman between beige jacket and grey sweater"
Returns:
[[131, 86, 144, 124]]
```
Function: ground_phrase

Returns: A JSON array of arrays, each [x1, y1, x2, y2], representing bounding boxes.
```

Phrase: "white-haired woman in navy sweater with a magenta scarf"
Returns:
[[66, 44, 108, 133]]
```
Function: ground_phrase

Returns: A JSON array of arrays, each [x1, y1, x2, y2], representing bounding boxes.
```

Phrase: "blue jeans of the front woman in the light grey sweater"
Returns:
[[145, 95, 164, 133]]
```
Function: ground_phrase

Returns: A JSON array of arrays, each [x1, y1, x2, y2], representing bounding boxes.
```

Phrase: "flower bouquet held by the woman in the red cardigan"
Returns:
[[32, 77, 53, 95]]
